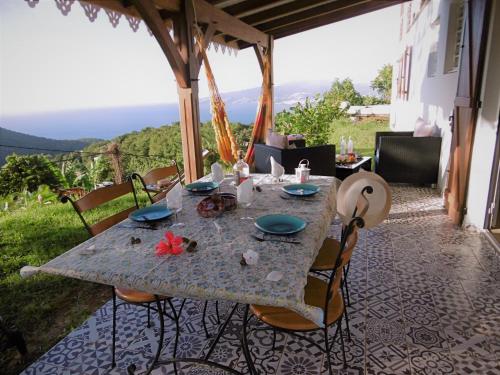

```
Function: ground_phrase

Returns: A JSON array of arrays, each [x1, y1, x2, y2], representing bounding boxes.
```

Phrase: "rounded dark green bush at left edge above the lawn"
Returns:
[[0, 154, 62, 196]]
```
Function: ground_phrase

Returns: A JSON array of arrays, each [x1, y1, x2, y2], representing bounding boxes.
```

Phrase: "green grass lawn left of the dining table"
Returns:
[[0, 192, 145, 374]]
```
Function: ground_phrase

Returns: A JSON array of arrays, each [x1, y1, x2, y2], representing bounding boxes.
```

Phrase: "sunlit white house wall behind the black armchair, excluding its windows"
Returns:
[[390, 0, 458, 189]]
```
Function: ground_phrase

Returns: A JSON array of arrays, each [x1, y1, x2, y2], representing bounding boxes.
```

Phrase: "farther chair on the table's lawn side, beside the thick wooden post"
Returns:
[[131, 160, 182, 203]]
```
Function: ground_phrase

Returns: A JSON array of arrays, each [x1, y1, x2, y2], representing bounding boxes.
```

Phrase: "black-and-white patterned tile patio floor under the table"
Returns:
[[21, 186, 500, 375]]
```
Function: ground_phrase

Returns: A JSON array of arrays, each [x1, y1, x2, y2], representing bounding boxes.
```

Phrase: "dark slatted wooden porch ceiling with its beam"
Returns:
[[87, 0, 407, 49]]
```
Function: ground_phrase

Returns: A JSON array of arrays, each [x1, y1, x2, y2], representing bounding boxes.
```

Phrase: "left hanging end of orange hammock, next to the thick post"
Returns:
[[198, 41, 238, 163]]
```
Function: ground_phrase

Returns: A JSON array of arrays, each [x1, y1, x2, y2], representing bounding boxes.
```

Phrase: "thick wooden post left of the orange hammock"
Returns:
[[173, 0, 203, 183]]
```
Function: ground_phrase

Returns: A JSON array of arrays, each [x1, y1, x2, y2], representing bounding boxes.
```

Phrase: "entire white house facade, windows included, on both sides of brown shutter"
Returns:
[[390, 0, 500, 232]]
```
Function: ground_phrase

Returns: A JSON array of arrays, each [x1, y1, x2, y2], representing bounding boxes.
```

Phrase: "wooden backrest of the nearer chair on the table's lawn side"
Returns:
[[61, 179, 139, 236]]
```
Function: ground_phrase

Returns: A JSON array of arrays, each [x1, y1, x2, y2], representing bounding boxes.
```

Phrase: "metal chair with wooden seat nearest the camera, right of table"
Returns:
[[242, 217, 364, 375]]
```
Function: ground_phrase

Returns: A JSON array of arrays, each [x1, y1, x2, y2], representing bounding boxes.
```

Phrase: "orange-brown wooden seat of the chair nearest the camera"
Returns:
[[250, 276, 344, 331]]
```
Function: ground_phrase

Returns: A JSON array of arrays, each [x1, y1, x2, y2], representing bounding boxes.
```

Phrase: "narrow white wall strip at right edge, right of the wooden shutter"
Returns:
[[464, 1, 500, 228]]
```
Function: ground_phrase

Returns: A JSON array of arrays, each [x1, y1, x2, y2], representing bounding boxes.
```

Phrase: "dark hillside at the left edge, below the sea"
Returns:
[[0, 127, 98, 166]]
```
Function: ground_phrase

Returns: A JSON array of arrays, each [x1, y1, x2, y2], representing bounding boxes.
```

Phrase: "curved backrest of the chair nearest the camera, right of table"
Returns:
[[324, 217, 364, 324]]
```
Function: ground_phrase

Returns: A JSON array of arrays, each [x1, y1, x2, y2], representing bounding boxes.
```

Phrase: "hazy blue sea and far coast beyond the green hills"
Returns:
[[0, 81, 373, 139]]
